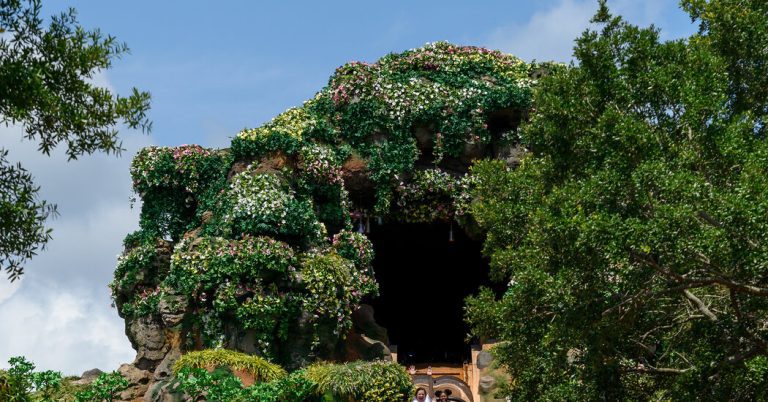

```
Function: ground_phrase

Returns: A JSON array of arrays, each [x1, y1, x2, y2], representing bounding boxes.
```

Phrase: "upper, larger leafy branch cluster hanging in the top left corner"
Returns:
[[0, 0, 150, 159]]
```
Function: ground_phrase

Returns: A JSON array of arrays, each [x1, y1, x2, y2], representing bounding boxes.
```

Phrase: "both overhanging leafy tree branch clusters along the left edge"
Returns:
[[0, 0, 151, 281]]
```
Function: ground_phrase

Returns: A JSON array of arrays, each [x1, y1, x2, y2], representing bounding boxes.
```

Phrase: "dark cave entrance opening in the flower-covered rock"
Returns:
[[366, 223, 499, 364]]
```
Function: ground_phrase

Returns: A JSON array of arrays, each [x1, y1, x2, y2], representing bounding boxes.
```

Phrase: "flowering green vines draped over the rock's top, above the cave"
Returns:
[[232, 42, 538, 214]]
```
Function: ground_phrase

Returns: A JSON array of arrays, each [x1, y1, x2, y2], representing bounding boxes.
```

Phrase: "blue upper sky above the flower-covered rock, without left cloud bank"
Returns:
[[56, 0, 690, 146]]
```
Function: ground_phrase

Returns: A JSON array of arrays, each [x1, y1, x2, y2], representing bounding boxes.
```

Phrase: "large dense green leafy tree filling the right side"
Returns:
[[467, 0, 768, 400]]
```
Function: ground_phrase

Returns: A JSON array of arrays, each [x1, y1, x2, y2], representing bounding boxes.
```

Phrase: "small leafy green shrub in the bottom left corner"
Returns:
[[0, 356, 62, 402]]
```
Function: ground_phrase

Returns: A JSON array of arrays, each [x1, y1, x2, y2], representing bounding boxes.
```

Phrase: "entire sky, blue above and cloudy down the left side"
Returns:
[[0, 0, 695, 374]]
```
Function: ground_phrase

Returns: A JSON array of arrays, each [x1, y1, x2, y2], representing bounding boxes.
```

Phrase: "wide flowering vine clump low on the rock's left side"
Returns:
[[162, 236, 300, 358]]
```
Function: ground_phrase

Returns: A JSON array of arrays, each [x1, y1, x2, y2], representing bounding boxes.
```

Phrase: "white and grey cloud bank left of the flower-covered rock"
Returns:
[[0, 121, 151, 374]]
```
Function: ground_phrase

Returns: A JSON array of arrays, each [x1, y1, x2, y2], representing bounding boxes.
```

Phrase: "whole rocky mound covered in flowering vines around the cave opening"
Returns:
[[110, 42, 533, 400]]
